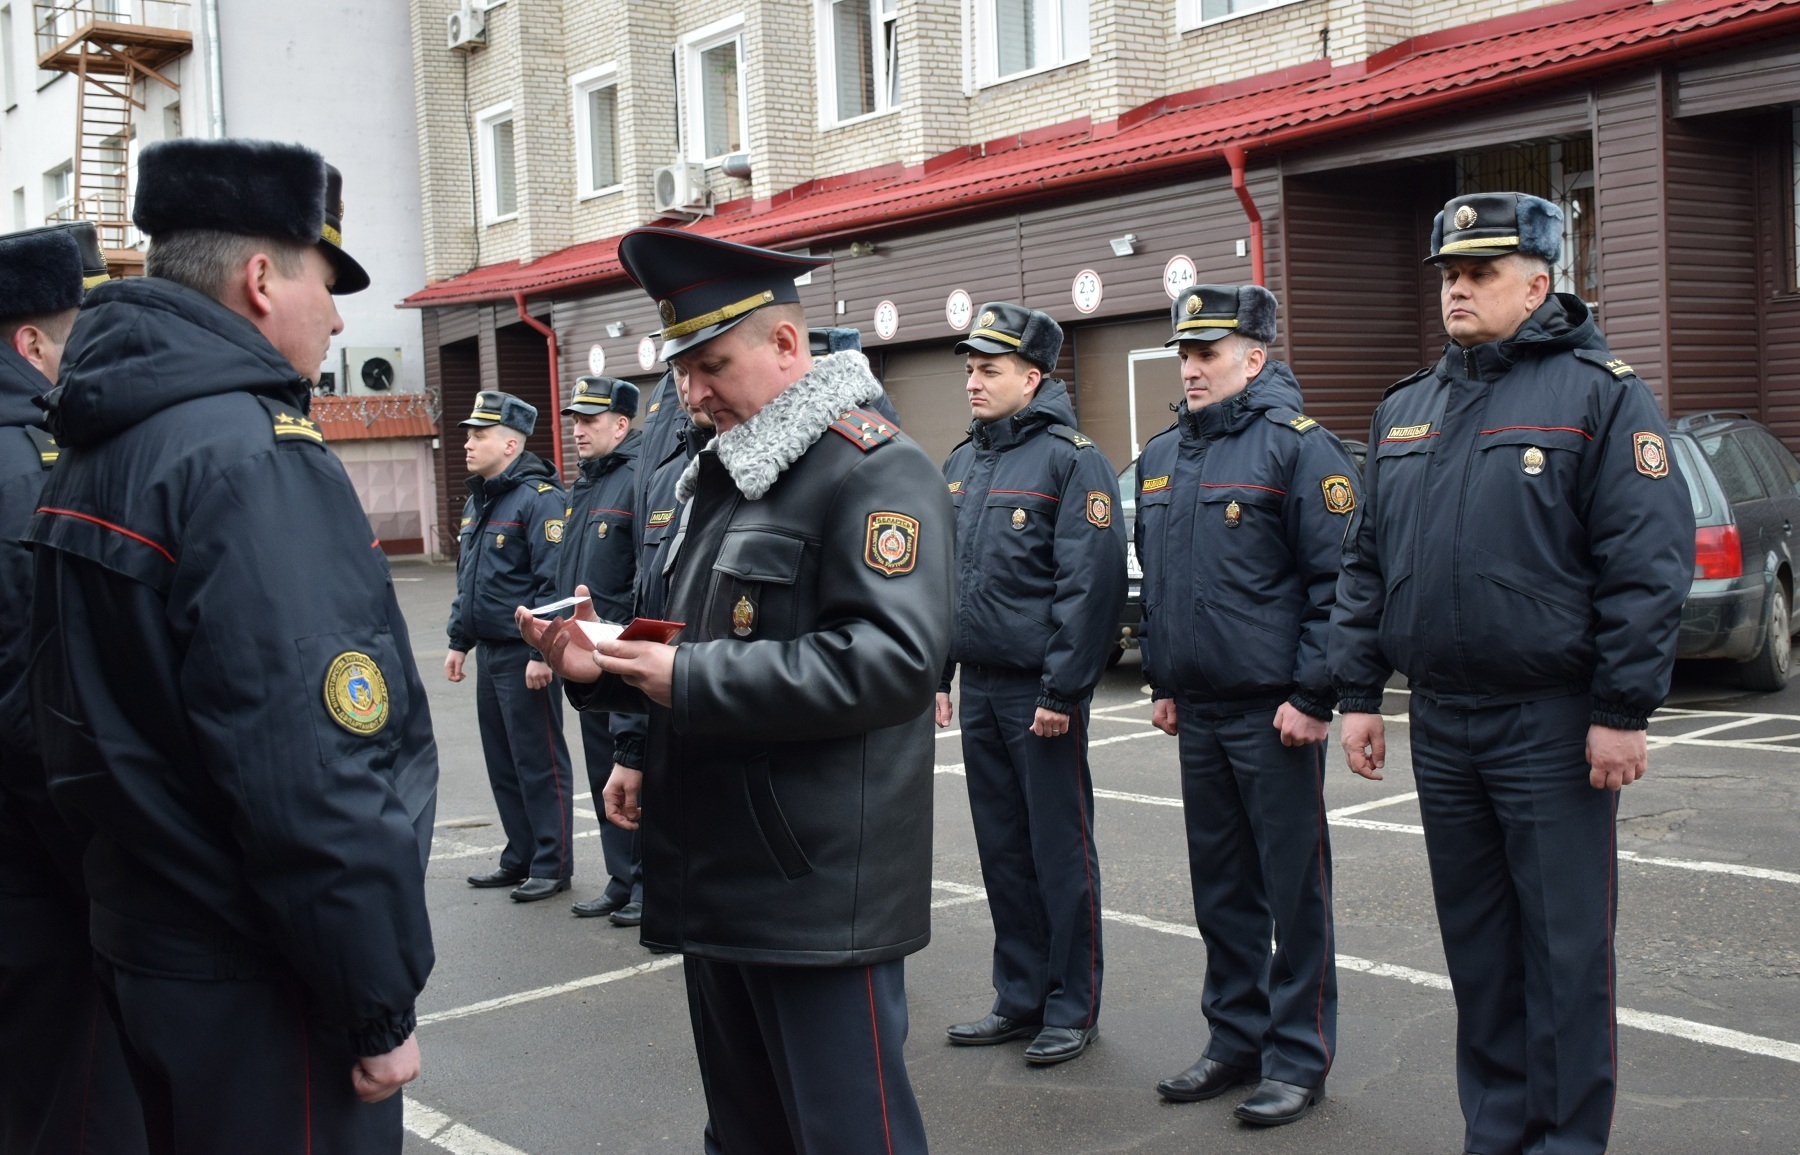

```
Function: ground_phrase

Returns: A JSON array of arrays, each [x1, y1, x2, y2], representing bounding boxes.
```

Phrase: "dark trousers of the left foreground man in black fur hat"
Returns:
[[95, 959, 401, 1155]]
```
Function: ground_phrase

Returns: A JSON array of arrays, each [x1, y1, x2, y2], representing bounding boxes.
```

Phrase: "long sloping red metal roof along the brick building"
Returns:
[[403, 0, 1800, 308]]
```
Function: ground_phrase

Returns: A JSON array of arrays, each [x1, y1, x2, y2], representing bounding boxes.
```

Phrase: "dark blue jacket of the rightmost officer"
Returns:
[[1330, 293, 1694, 729]]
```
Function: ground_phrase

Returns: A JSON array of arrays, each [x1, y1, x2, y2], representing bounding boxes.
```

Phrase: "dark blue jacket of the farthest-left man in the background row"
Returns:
[[450, 450, 574, 653]]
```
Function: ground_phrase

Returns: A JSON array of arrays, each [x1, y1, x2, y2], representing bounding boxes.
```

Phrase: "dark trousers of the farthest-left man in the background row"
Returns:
[[475, 639, 574, 878]]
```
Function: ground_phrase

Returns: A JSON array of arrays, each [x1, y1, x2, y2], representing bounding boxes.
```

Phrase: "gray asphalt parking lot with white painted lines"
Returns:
[[394, 563, 1800, 1155]]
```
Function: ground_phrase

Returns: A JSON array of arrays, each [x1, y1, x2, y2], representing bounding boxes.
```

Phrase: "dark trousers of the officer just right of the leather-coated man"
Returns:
[[961, 664, 1105, 1027]]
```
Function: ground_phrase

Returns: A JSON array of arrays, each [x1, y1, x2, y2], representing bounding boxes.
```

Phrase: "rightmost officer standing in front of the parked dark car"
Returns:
[[1330, 193, 1694, 1153]]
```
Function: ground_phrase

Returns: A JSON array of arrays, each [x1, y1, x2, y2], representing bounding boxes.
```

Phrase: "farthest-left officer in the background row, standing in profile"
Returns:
[[445, 390, 574, 903]]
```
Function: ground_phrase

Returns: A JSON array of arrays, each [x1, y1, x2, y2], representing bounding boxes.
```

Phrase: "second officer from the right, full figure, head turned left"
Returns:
[[1134, 284, 1355, 1124]]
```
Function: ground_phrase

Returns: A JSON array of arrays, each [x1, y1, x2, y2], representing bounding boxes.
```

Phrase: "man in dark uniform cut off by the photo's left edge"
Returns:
[[0, 221, 144, 1153]]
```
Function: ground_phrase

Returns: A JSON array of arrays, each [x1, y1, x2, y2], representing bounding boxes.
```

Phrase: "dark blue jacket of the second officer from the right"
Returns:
[[1136, 362, 1355, 721]]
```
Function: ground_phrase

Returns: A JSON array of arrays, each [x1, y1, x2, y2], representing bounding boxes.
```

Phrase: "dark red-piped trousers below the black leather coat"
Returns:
[[684, 955, 925, 1155]]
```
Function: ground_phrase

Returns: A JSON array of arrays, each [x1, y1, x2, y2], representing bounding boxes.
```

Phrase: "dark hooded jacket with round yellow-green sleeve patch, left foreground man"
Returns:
[[29, 277, 437, 1054]]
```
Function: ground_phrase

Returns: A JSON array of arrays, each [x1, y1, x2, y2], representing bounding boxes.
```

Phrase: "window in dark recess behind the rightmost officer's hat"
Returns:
[[1456, 137, 1600, 308]]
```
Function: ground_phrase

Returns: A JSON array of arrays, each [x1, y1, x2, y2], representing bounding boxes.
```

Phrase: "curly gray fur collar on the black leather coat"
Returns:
[[675, 349, 882, 502]]
